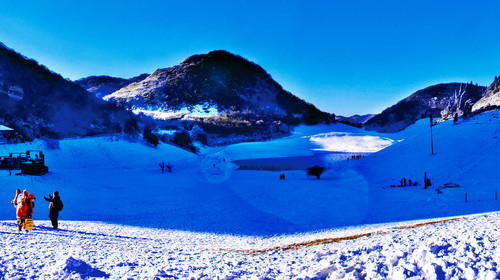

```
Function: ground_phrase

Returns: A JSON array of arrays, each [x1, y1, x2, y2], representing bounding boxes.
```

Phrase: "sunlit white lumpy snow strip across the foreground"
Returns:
[[0, 213, 500, 279]]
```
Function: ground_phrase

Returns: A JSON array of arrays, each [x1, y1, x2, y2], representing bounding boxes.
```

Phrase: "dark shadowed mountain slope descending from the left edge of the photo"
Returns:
[[0, 44, 134, 140]]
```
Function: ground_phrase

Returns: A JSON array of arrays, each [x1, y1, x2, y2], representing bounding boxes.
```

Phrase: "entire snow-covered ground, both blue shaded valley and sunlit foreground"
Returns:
[[0, 111, 500, 279]]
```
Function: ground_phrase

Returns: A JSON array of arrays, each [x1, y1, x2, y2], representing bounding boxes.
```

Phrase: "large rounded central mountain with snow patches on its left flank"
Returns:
[[104, 51, 332, 126]]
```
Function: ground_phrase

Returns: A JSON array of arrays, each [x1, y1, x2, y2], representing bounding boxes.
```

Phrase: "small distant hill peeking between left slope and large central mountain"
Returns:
[[75, 74, 149, 98]]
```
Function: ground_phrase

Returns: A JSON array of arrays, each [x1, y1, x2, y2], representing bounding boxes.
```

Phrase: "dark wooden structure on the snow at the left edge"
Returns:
[[0, 150, 49, 175]]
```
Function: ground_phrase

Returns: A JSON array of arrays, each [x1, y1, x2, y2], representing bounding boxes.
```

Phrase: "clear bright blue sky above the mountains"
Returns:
[[0, 0, 500, 115]]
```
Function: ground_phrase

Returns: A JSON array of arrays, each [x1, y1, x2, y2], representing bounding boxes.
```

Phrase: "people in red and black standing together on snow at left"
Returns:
[[12, 189, 63, 231]]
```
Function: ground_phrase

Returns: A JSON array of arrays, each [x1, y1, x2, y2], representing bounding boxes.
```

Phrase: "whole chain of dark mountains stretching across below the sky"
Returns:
[[0, 40, 500, 139]]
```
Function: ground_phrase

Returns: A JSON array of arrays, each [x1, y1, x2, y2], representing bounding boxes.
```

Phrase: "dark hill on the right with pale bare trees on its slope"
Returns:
[[364, 83, 486, 132]]
